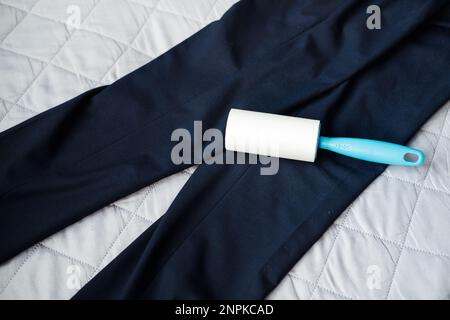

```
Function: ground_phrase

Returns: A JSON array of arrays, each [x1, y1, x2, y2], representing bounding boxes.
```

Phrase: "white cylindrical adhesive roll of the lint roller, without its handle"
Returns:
[[225, 109, 320, 162]]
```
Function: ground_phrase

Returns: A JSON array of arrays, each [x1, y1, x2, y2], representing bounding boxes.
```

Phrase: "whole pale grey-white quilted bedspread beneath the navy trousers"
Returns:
[[0, 0, 450, 299]]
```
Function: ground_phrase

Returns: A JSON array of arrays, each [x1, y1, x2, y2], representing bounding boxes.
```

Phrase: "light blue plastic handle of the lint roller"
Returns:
[[319, 137, 425, 166]]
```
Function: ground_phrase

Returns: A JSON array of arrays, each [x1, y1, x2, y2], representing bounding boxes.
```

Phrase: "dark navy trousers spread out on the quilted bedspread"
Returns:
[[0, 0, 450, 299]]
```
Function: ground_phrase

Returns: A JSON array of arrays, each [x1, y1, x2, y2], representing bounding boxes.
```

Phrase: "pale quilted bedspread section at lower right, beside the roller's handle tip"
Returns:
[[268, 102, 450, 299]]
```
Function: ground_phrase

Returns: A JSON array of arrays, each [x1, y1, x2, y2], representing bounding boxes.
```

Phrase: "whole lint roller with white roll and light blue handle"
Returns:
[[225, 109, 425, 166]]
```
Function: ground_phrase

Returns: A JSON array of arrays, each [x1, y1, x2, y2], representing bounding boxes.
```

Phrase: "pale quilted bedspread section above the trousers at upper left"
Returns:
[[0, 0, 236, 130]]
